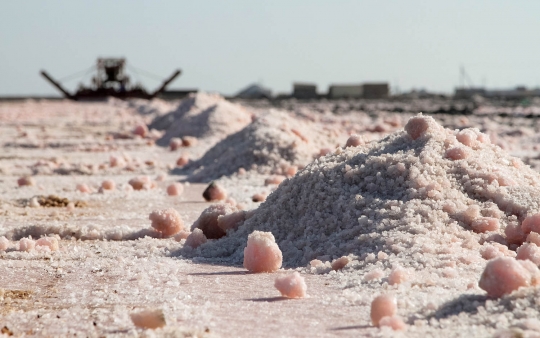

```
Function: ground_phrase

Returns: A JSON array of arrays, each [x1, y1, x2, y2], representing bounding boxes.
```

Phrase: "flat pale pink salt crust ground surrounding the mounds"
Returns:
[[0, 96, 540, 337]]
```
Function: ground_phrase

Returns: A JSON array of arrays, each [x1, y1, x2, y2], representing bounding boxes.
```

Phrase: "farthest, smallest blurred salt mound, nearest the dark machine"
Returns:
[[149, 92, 251, 146]]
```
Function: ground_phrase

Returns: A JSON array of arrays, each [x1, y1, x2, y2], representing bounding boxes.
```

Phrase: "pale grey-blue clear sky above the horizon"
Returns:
[[0, 0, 540, 96]]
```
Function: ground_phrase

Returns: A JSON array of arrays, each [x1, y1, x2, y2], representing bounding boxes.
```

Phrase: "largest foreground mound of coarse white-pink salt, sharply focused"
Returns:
[[197, 116, 540, 273]]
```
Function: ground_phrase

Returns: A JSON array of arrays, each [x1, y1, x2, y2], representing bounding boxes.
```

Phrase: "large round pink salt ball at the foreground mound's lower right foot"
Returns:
[[478, 257, 531, 298]]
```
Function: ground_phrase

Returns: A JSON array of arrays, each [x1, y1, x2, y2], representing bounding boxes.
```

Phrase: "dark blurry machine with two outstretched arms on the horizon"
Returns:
[[41, 58, 181, 100]]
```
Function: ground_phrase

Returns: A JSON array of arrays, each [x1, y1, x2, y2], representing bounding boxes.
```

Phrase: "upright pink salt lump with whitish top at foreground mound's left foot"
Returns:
[[244, 231, 283, 272]]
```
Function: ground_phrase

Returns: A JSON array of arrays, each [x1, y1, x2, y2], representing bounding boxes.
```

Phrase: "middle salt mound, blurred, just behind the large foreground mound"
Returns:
[[177, 110, 337, 181]]
